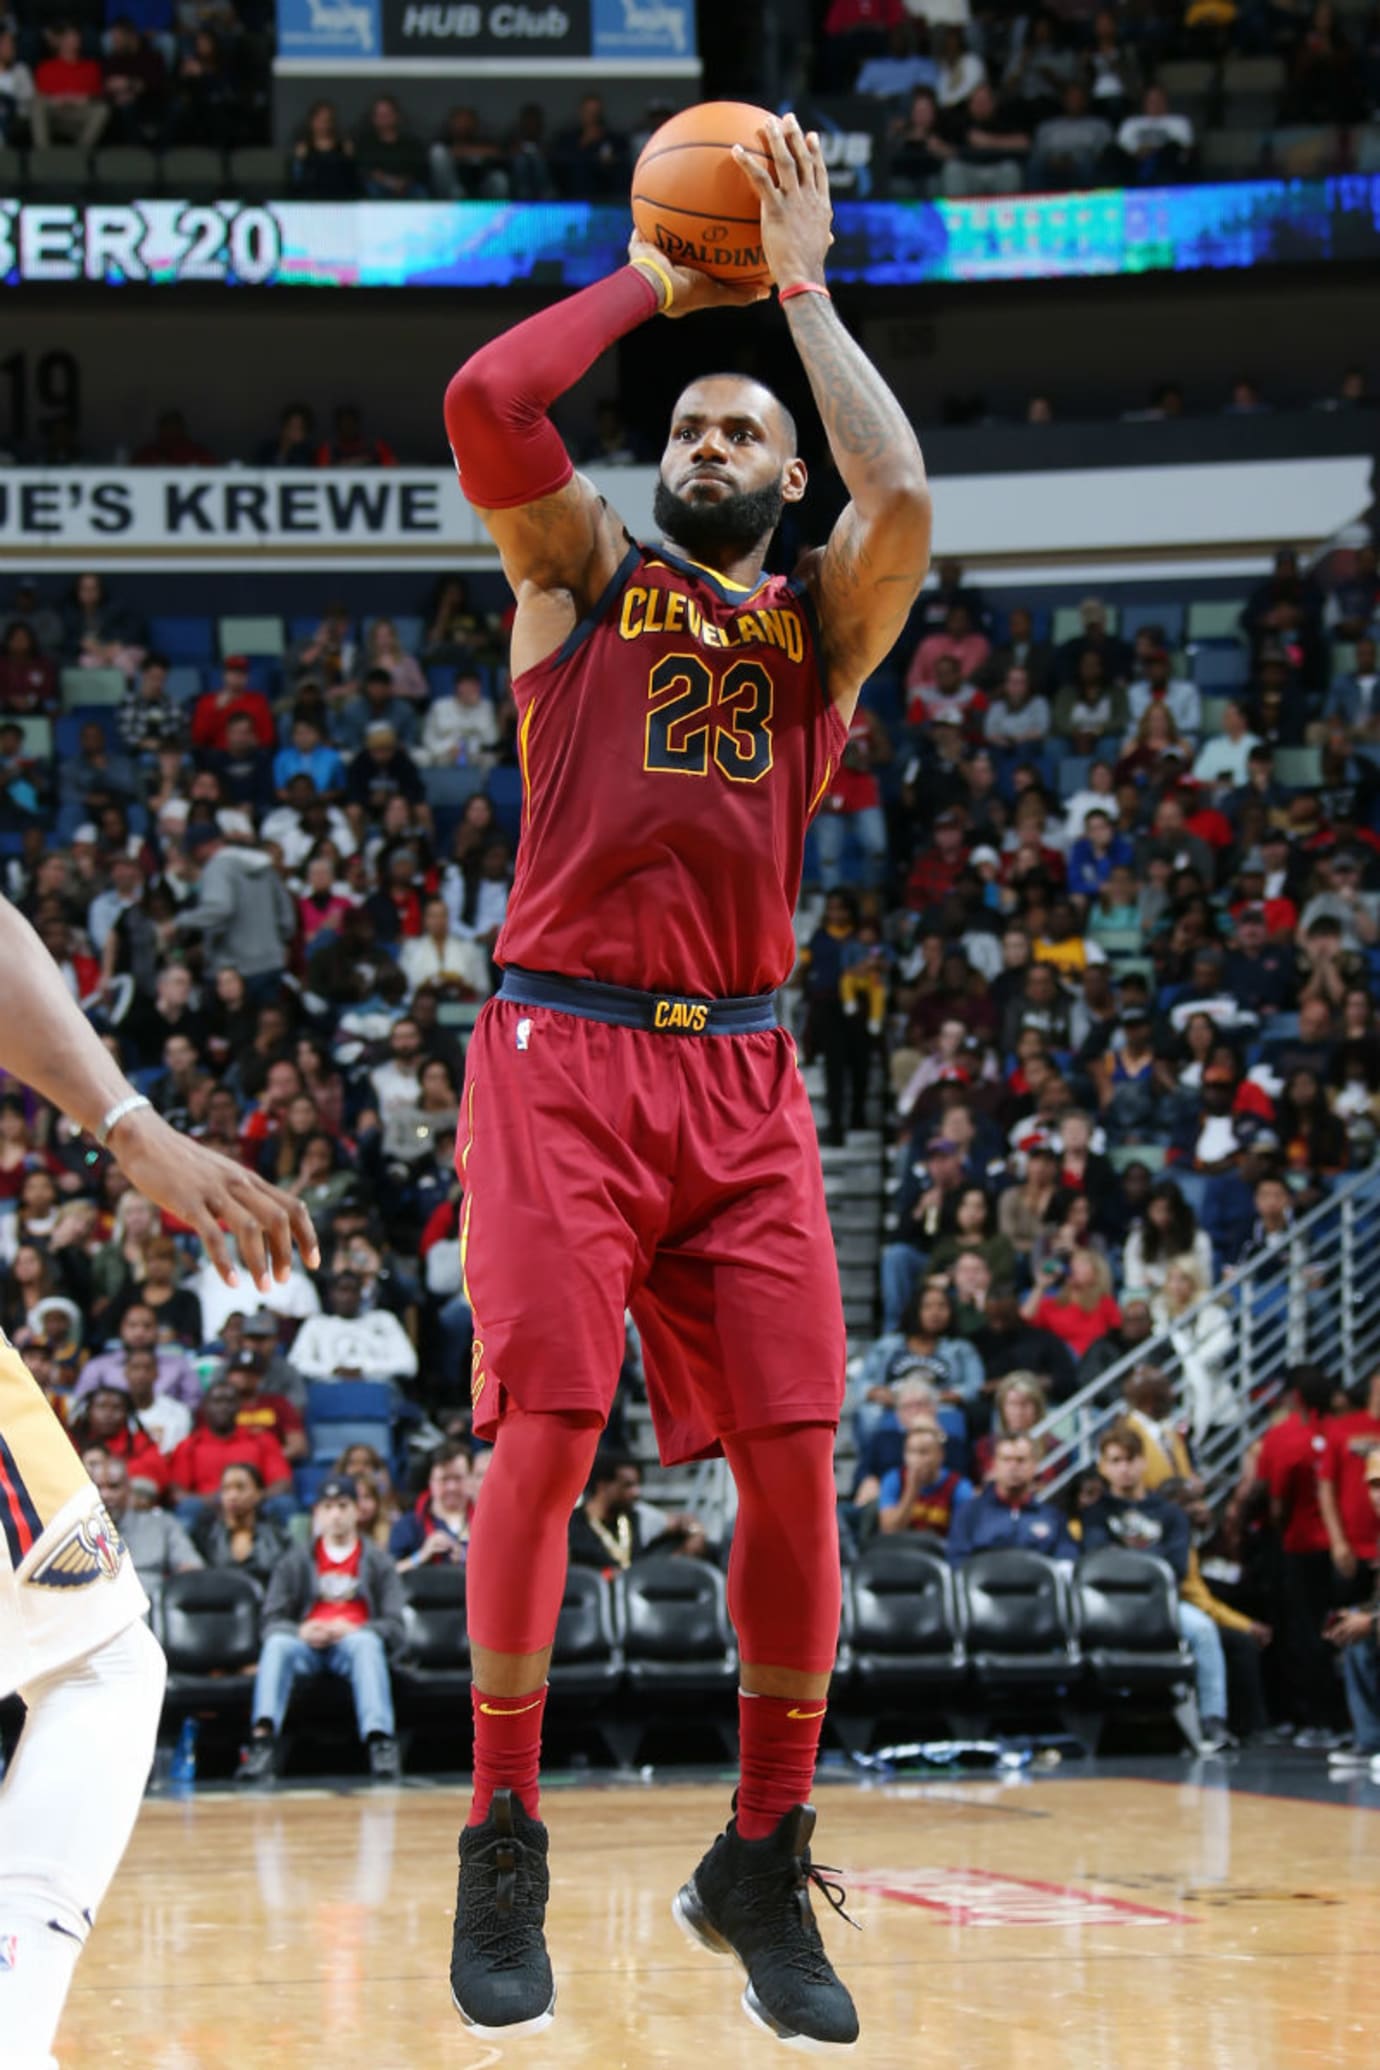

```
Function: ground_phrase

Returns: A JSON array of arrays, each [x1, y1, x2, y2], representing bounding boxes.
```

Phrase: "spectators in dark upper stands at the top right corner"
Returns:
[[815, 0, 1380, 199]]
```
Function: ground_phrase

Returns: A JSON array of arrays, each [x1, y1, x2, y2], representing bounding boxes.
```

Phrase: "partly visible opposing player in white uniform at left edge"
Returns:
[[0, 898, 317, 2070]]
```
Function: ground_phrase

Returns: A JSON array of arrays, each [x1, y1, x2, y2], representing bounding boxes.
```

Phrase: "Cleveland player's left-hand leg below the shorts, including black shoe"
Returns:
[[451, 1408, 602, 2039]]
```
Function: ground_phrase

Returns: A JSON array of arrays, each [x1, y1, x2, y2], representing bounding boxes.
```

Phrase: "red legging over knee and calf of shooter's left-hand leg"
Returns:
[[466, 1406, 602, 1654]]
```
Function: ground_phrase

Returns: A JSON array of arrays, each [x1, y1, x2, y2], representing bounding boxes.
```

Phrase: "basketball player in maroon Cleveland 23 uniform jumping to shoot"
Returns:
[[445, 116, 929, 2045]]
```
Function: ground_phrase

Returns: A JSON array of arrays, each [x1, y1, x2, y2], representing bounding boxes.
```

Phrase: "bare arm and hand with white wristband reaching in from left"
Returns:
[[0, 898, 319, 1292]]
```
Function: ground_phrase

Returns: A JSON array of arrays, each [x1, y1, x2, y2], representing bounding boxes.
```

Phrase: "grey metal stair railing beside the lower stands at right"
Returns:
[[1034, 1165, 1380, 1501]]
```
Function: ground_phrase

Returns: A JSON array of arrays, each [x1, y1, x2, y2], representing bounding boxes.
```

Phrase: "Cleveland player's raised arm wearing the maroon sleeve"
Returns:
[[445, 250, 766, 673]]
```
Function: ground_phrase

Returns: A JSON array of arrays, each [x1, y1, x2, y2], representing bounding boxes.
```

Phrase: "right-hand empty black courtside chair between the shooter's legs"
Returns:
[[614, 1555, 739, 1702]]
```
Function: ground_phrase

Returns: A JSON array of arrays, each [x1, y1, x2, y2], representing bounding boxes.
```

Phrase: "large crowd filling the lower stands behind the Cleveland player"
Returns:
[[0, 517, 1380, 1774]]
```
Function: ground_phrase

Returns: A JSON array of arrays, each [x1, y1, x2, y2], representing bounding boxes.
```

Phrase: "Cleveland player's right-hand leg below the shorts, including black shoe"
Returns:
[[674, 1424, 859, 2047]]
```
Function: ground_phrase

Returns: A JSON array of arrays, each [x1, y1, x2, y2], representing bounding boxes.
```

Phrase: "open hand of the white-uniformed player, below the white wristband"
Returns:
[[110, 1107, 321, 1294]]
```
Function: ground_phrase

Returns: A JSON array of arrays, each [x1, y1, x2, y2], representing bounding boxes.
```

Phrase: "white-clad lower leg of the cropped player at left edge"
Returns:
[[0, 1623, 168, 2070]]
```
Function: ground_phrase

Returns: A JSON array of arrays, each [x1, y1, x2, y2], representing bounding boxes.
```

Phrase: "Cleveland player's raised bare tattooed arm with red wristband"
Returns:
[[734, 116, 931, 718]]
